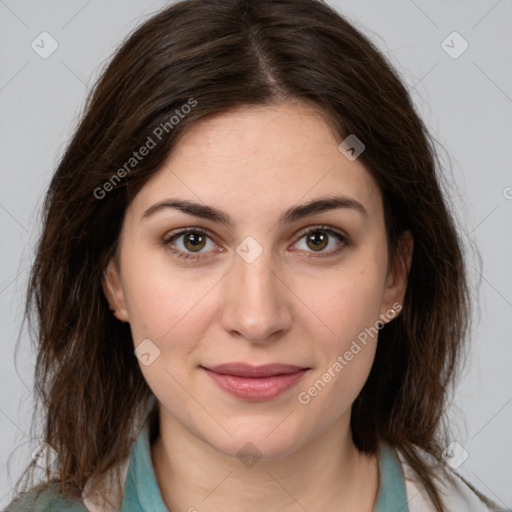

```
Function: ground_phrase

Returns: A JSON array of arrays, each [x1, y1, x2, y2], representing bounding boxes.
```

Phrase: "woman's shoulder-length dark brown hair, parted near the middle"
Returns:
[[7, 0, 470, 512]]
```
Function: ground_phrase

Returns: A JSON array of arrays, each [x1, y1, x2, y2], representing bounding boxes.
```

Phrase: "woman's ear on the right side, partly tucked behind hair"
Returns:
[[381, 231, 414, 323]]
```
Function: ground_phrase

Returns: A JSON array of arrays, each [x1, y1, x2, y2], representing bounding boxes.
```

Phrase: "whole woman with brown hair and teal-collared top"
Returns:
[[2, 0, 502, 512]]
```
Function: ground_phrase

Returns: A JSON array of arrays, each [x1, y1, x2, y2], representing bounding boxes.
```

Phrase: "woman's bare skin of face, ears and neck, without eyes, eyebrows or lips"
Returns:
[[103, 101, 413, 512]]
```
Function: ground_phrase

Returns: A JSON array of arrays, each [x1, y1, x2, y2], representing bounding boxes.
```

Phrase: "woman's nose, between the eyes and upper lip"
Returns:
[[222, 251, 293, 343]]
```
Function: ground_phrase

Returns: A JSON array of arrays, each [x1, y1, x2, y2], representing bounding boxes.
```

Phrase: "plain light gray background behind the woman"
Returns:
[[0, 0, 512, 508]]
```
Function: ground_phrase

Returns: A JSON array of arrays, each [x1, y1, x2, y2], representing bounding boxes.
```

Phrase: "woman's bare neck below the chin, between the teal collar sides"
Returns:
[[151, 411, 379, 512]]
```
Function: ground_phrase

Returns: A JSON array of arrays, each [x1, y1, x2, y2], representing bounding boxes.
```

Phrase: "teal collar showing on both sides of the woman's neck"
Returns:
[[120, 422, 409, 512]]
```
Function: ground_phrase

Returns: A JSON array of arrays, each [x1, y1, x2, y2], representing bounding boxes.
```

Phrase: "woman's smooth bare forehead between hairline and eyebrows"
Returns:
[[128, 101, 382, 225]]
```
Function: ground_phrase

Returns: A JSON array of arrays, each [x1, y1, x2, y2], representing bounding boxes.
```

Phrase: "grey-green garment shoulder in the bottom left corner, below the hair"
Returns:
[[4, 488, 87, 512]]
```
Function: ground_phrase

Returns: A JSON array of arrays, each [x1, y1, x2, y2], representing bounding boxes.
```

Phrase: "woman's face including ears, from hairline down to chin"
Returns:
[[104, 103, 412, 458]]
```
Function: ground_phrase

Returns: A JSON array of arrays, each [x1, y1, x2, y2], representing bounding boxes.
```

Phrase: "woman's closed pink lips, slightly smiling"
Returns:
[[201, 363, 309, 401]]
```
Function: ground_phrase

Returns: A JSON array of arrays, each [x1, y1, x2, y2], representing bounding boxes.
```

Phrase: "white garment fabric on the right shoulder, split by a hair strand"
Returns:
[[397, 450, 506, 512]]
